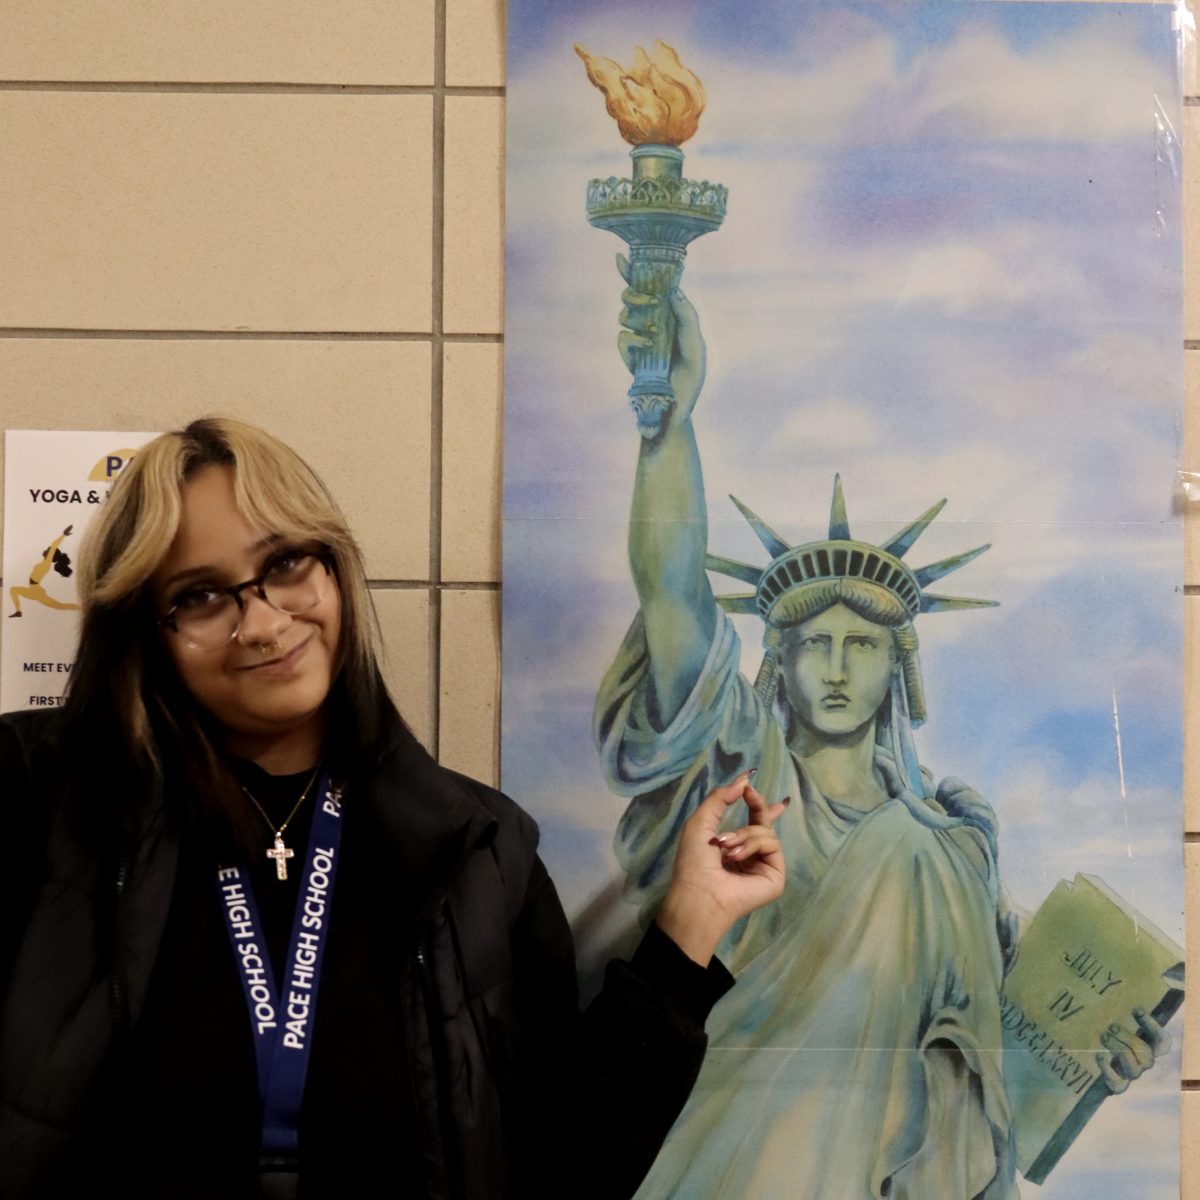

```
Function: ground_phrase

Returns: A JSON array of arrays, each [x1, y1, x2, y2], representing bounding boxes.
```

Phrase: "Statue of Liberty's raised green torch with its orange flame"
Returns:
[[575, 41, 728, 438]]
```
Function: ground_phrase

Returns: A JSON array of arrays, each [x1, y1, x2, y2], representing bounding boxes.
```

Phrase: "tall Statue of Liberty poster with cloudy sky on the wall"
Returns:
[[503, 0, 1184, 1200]]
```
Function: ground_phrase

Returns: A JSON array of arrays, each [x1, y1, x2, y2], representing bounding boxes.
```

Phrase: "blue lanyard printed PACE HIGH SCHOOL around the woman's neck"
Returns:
[[217, 773, 344, 1157]]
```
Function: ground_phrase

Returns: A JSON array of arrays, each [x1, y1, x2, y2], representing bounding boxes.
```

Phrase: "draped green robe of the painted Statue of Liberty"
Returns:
[[596, 616, 1016, 1200]]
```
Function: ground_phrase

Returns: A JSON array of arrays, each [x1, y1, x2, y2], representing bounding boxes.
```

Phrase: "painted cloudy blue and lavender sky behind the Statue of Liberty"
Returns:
[[503, 0, 1182, 1200]]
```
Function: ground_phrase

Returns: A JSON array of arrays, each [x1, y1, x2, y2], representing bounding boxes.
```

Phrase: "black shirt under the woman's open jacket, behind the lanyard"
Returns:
[[100, 763, 425, 1198]]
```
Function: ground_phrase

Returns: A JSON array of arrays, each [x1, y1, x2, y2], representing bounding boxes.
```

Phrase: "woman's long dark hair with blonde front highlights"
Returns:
[[64, 418, 390, 801]]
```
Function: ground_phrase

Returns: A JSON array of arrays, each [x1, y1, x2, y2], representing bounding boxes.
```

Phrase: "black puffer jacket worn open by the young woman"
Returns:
[[0, 713, 731, 1200]]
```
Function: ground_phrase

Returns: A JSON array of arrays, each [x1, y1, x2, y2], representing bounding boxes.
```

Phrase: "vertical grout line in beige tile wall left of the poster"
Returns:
[[430, 0, 446, 760]]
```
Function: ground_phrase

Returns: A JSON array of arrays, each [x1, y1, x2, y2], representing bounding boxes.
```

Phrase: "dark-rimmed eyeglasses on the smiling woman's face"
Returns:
[[158, 550, 330, 650]]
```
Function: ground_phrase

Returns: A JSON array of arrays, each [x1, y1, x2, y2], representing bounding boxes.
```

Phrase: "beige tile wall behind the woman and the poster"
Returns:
[[0, 0, 1200, 1171]]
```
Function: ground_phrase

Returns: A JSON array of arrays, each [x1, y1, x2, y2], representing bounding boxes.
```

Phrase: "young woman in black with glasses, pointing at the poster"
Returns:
[[0, 420, 782, 1198]]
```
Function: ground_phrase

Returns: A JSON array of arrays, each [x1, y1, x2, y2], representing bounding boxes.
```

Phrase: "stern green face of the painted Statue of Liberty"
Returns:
[[779, 604, 896, 738]]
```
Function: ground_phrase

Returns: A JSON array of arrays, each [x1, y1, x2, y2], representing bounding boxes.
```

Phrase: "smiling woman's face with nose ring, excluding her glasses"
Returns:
[[151, 467, 341, 756]]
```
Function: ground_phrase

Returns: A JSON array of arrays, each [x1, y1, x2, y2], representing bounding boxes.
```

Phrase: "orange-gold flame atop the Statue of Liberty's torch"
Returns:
[[575, 38, 704, 146]]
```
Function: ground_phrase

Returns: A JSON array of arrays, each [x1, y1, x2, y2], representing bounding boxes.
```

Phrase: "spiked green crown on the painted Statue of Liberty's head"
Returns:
[[704, 475, 996, 624]]
